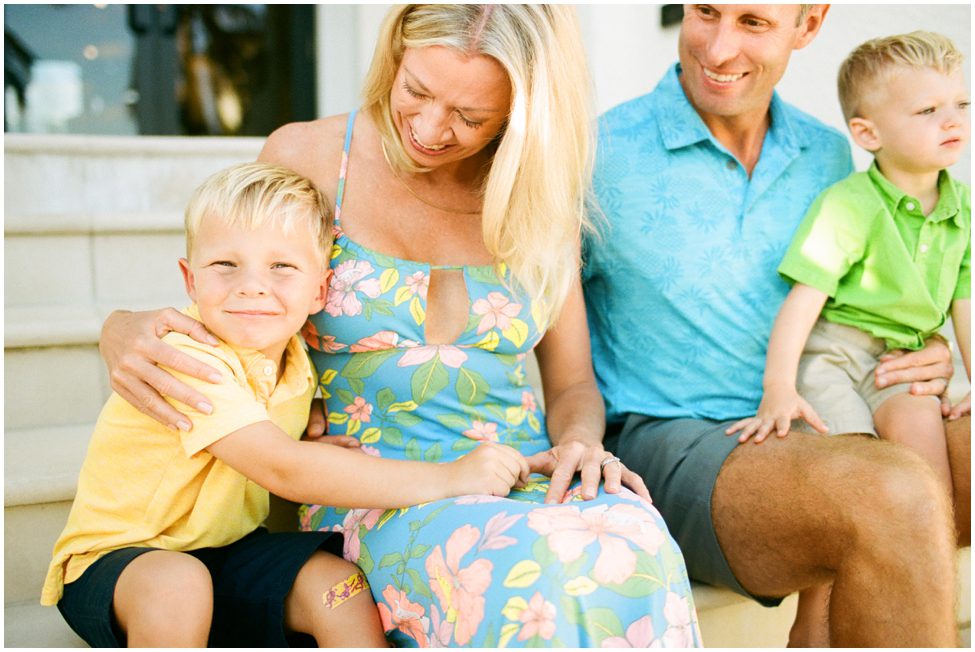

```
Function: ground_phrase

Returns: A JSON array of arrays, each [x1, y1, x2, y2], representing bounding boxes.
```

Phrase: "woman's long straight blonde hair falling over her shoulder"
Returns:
[[363, 4, 595, 327]]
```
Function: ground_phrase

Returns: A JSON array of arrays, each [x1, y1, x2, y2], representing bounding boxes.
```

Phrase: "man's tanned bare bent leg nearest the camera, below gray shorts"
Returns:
[[712, 433, 957, 647]]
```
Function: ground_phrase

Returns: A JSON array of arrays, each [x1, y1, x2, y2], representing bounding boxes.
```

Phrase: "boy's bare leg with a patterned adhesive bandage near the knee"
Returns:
[[284, 551, 389, 647]]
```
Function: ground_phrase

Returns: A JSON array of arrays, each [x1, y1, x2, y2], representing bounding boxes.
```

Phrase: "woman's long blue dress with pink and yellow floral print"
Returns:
[[300, 114, 701, 647]]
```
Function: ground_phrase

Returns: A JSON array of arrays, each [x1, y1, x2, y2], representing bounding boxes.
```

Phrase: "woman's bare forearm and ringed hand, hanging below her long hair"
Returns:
[[528, 280, 650, 503]]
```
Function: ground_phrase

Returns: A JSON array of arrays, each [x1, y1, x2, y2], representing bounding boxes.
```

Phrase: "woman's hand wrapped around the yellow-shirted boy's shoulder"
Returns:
[[98, 308, 223, 430]]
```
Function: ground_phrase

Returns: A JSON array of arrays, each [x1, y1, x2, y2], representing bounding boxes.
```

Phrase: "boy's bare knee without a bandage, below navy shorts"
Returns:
[[113, 550, 213, 647]]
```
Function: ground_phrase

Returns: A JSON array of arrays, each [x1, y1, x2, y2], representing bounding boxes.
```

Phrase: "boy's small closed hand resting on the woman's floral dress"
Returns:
[[447, 442, 529, 497]]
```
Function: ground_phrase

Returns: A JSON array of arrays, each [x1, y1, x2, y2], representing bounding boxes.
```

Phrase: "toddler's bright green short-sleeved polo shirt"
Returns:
[[779, 162, 972, 350]]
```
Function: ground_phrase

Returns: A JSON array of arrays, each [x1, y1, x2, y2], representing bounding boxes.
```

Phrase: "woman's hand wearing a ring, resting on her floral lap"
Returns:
[[527, 441, 650, 503]]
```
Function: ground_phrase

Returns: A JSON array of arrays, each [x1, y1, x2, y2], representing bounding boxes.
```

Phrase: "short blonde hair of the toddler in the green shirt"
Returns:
[[838, 31, 963, 122]]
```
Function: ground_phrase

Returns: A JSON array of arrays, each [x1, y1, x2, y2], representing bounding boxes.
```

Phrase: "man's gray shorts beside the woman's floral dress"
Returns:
[[606, 414, 783, 607]]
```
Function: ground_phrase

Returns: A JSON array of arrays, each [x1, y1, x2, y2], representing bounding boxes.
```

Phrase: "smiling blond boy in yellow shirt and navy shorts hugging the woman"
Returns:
[[41, 163, 528, 647]]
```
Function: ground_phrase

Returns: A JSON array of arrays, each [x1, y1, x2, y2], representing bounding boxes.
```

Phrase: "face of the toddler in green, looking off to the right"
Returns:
[[864, 68, 970, 173]]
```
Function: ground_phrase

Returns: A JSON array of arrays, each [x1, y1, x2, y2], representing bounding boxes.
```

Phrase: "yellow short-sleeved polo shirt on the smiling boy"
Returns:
[[41, 306, 315, 605]]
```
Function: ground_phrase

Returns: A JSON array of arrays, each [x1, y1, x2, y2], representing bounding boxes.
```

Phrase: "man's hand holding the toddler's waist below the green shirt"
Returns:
[[874, 337, 955, 416]]
